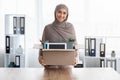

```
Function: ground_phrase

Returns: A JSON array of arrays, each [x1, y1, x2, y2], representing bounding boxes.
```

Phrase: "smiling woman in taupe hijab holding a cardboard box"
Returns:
[[39, 4, 77, 67]]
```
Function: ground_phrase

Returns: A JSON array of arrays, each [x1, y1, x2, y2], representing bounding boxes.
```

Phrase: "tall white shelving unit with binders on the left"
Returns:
[[4, 14, 25, 67]]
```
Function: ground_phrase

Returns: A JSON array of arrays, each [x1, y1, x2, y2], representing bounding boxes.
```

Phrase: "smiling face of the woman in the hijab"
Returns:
[[56, 9, 68, 22]]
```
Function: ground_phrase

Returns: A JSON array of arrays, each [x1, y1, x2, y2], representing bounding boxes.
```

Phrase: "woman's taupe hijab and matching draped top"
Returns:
[[42, 4, 76, 43]]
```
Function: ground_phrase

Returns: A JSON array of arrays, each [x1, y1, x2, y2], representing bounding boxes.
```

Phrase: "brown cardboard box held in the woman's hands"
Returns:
[[42, 49, 75, 65]]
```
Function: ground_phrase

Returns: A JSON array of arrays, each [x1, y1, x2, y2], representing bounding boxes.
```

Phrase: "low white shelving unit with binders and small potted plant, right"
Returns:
[[84, 36, 120, 71]]
